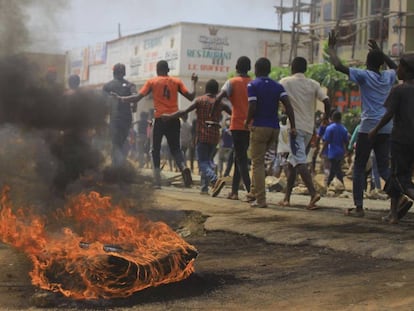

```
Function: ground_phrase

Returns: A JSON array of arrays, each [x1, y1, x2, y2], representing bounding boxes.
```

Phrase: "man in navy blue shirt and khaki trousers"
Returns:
[[244, 57, 296, 208]]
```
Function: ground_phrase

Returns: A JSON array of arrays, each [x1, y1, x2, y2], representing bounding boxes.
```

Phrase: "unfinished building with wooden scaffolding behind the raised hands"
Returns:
[[314, 0, 414, 64]]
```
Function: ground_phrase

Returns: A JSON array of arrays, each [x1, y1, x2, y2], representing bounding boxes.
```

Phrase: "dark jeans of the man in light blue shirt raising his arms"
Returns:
[[352, 133, 390, 207]]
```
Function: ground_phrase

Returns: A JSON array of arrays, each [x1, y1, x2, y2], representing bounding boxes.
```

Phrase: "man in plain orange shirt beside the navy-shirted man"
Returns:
[[216, 56, 251, 200]]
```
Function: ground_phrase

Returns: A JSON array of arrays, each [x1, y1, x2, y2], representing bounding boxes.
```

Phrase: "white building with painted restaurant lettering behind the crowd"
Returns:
[[67, 22, 308, 116]]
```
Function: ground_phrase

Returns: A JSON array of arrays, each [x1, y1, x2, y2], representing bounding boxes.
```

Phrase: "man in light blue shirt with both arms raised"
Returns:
[[328, 30, 397, 217]]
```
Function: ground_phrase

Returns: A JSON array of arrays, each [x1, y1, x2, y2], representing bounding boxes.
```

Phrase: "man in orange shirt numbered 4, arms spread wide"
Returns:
[[115, 60, 198, 189]]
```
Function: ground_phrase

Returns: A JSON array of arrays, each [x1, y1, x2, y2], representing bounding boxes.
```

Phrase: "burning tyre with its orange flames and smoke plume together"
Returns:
[[0, 0, 197, 299]]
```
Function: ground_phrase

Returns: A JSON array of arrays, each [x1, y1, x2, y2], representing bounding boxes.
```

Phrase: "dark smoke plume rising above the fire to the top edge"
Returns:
[[0, 0, 108, 197]]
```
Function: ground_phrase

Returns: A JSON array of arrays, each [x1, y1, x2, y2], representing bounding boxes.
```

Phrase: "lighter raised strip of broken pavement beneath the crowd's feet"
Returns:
[[148, 169, 414, 261]]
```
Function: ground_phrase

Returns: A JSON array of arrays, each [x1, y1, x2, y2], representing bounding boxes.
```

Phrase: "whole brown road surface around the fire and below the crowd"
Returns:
[[0, 187, 414, 311]]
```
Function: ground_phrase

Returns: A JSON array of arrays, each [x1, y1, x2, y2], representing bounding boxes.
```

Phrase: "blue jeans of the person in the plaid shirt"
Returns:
[[197, 143, 217, 192]]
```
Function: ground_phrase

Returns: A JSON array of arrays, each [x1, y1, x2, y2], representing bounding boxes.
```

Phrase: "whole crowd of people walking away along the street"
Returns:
[[98, 31, 414, 223]]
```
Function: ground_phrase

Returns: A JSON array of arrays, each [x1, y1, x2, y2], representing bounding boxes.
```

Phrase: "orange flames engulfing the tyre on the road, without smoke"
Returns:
[[0, 186, 197, 299]]
